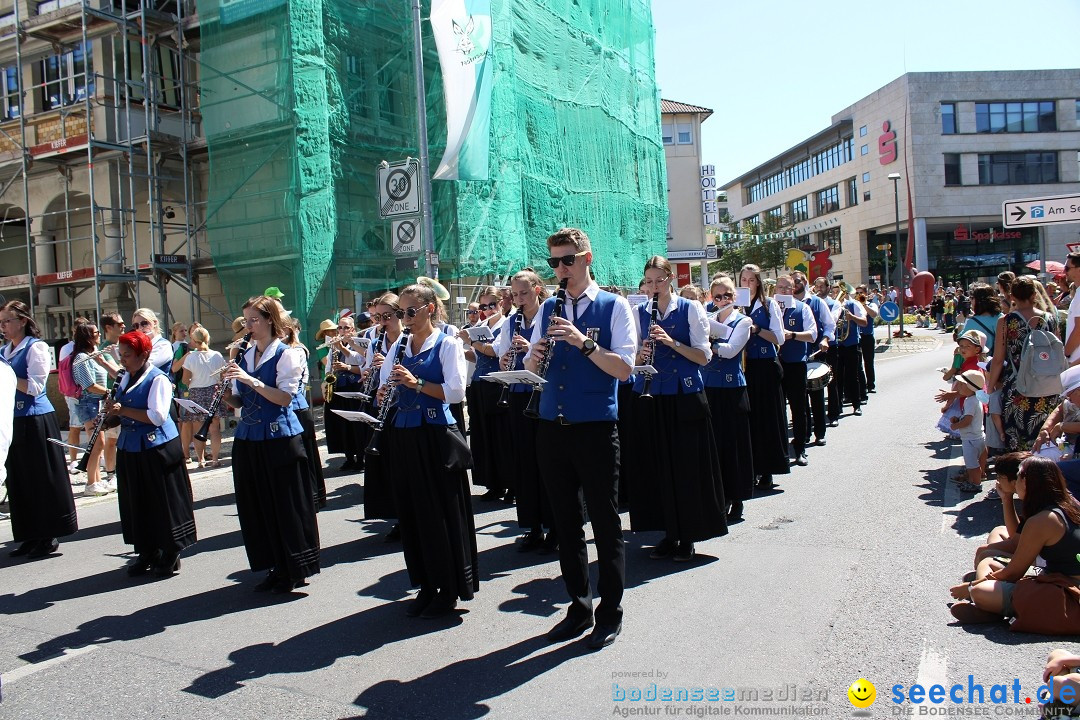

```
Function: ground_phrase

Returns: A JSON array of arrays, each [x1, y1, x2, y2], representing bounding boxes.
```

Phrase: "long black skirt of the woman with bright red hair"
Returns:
[[117, 437, 198, 554]]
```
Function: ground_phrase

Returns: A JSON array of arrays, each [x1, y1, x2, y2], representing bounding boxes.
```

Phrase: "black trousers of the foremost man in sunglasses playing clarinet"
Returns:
[[537, 420, 626, 625]]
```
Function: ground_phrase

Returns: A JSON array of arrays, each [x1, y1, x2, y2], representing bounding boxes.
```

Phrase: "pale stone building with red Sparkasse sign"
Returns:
[[724, 69, 1080, 283]]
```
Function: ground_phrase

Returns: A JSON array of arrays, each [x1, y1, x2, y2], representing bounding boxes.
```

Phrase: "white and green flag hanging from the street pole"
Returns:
[[431, 0, 495, 180]]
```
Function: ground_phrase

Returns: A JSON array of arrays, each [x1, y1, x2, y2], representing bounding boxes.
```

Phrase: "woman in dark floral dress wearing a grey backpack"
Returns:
[[987, 276, 1065, 450]]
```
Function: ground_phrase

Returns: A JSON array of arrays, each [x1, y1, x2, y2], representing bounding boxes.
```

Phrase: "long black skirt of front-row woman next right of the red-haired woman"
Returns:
[[232, 435, 319, 581]]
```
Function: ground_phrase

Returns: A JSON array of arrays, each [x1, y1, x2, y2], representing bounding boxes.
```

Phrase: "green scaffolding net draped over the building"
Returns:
[[198, 0, 667, 329]]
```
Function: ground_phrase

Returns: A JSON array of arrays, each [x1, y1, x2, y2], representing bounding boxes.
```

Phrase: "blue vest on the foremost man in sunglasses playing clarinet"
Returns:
[[540, 290, 619, 423]]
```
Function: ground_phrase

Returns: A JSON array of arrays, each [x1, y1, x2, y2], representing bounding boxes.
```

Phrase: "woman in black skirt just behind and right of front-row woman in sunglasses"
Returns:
[[468, 287, 513, 501]]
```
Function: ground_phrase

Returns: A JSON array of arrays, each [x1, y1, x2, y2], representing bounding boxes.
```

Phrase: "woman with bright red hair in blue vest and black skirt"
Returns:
[[107, 331, 195, 578]]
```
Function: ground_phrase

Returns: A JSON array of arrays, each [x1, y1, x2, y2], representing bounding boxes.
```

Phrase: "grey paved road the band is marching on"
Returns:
[[0, 330, 1061, 719]]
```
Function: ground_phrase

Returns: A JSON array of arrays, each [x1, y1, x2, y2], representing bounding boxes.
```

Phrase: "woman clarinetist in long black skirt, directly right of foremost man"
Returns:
[[623, 255, 728, 562]]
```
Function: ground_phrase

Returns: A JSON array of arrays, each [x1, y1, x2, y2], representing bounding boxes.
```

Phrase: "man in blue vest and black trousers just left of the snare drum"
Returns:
[[777, 274, 818, 465]]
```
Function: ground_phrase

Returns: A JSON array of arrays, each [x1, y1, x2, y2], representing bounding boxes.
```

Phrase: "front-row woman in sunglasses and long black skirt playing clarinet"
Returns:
[[379, 284, 480, 617]]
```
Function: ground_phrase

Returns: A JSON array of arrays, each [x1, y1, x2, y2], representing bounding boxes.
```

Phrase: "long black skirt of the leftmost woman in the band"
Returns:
[[5, 412, 79, 542]]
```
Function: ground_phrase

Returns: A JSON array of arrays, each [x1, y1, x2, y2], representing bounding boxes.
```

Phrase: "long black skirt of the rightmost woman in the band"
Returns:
[[746, 359, 792, 475]]
